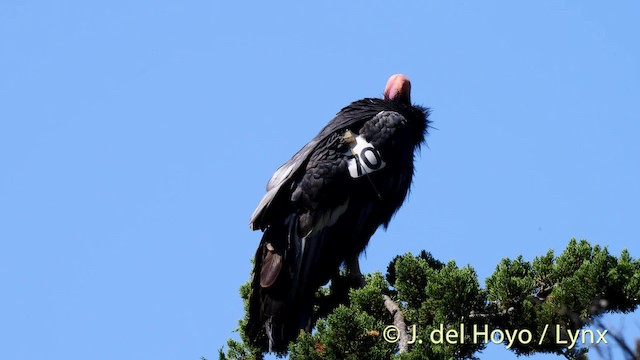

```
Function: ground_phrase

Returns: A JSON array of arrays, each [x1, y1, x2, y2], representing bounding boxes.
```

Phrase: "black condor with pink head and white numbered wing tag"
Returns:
[[245, 74, 429, 351]]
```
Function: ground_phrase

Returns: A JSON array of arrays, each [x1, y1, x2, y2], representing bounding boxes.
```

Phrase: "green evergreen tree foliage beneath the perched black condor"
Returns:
[[219, 239, 640, 360]]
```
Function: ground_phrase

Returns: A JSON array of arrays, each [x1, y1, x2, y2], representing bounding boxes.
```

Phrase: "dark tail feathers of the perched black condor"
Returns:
[[246, 215, 314, 352]]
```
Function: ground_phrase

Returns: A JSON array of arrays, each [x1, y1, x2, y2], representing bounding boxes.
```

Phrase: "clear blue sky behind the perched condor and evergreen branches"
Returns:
[[0, 0, 640, 360]]
